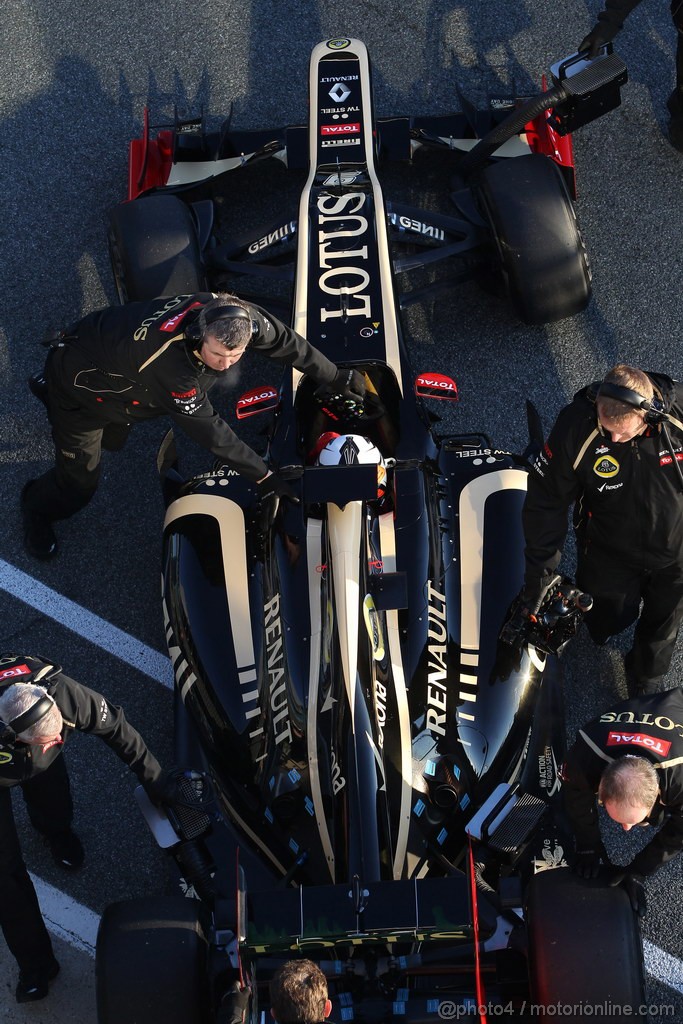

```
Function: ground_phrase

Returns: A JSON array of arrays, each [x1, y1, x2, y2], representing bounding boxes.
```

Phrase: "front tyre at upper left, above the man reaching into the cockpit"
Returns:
[[109, 196, 206, 303]]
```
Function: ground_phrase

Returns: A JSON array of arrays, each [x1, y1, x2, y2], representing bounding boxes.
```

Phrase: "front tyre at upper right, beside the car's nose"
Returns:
[[477, 153, 591, 324]]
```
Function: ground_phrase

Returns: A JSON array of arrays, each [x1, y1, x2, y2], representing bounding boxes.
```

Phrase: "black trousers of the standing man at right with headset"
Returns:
[[577, 544, 683, 692]]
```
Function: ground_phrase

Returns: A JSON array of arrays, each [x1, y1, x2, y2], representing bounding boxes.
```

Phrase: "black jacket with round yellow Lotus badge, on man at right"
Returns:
[[523, 374, 683, 583]]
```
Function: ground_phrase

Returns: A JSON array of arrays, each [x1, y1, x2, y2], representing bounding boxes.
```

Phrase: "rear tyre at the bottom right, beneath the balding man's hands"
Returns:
[[526, 867, 646, 1022]]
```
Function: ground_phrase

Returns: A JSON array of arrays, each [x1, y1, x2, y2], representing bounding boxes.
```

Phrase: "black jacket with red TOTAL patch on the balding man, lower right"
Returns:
[[562, 687, 683, 874]]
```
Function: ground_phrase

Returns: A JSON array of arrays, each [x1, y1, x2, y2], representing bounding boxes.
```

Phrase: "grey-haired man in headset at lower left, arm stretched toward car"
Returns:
[[0, 654, 183, 1002]]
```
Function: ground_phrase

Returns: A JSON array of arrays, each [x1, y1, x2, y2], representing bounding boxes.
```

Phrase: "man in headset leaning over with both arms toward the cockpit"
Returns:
[[22, 292, 365, 559]]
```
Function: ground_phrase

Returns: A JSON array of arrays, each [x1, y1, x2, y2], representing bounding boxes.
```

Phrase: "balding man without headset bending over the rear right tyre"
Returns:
[[562, 687, 683, 912]]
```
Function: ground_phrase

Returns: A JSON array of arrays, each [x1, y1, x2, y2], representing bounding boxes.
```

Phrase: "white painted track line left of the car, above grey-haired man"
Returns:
[[0, 558, 173, 690]]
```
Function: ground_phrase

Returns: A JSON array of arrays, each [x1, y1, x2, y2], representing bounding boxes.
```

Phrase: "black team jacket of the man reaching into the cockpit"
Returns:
[[52, 293, 337, 480]]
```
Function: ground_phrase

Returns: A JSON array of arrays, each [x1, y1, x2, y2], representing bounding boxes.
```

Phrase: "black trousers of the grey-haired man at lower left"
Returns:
[[0, 757, 74, 971]]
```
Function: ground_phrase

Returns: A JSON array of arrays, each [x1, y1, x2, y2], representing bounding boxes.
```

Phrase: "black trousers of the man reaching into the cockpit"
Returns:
[[24, 349, 130, 521]]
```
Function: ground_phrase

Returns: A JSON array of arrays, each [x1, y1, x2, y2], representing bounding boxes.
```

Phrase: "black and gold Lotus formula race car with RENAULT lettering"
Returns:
[[97, 38, 644, 1024]]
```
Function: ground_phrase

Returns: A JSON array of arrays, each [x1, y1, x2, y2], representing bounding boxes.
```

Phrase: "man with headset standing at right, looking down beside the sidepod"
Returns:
[[520, 364, 683, 695]]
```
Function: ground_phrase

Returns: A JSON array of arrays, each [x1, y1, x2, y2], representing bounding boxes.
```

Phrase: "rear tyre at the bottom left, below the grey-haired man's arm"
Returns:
[[95, 896, 207, 1024]]
